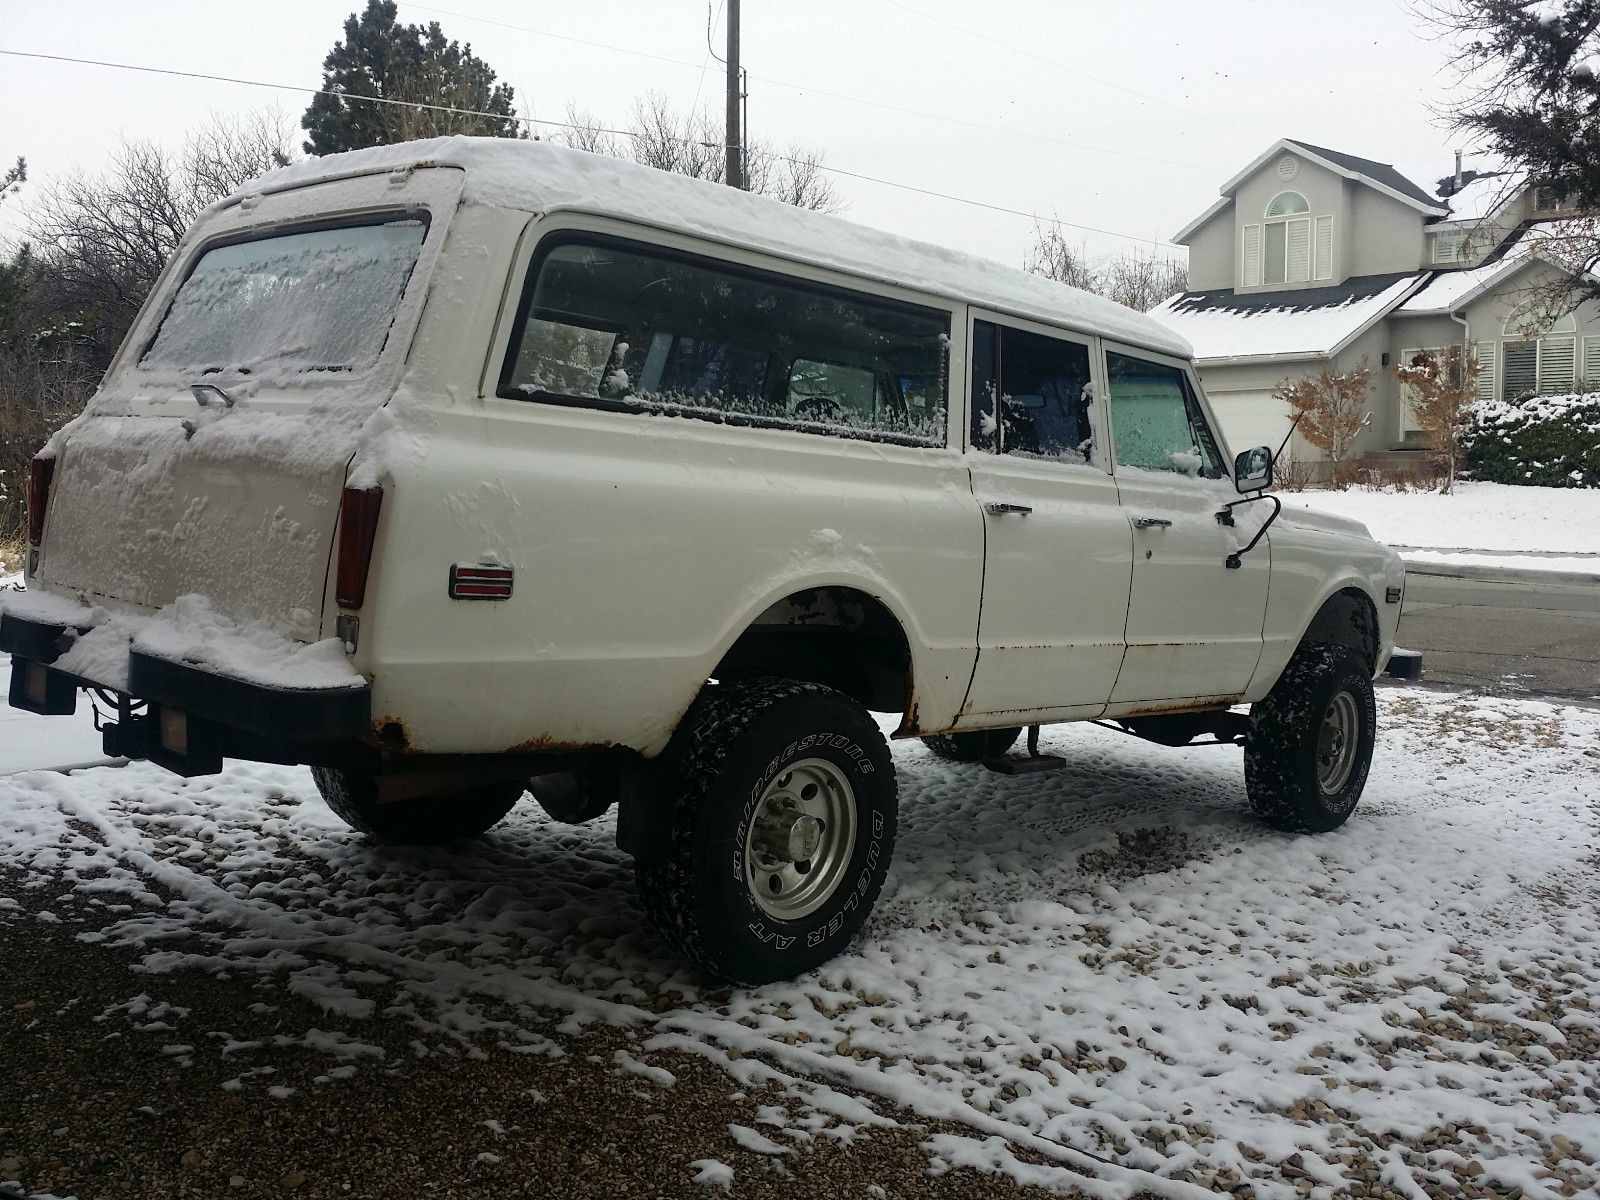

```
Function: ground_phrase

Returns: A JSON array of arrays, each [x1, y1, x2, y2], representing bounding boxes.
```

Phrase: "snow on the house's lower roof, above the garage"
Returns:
[[1150, 272, 1427, 363]]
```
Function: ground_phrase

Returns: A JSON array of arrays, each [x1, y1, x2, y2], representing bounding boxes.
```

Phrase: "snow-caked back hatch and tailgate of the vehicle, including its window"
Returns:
[[35, 168, 462, 640]]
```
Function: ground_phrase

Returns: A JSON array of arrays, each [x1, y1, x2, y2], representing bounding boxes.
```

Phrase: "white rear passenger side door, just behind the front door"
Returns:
[[958, 317, 1133, 728]]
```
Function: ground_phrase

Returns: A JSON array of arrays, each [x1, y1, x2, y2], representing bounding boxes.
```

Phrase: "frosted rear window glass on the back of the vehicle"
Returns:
[[139, 213, 427, 373]]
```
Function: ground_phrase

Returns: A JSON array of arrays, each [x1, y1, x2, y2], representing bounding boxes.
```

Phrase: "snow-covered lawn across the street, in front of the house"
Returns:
[[1278, 483, 1600, 574]]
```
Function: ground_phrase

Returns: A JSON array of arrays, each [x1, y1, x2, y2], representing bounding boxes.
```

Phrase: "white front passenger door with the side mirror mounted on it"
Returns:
[[1106, 346, 1272, 715]]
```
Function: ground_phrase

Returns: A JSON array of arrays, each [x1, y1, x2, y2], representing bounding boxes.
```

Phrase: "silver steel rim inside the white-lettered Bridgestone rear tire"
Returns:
[[744, 758, 856, 922]]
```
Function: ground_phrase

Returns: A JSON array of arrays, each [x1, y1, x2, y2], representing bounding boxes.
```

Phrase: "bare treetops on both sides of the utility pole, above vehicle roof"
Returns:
[[558, 91, 843, 213]]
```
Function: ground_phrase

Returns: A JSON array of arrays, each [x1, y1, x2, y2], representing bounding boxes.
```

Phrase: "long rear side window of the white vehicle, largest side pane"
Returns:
[[498, 235, 950, 445]]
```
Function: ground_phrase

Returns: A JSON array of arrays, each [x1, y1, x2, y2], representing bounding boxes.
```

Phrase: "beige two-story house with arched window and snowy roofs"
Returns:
[[1150, 138, 1600, 469]]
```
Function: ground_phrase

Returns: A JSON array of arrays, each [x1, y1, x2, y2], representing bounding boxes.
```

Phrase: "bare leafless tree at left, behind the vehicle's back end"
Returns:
[[29, 114, 293, 368]]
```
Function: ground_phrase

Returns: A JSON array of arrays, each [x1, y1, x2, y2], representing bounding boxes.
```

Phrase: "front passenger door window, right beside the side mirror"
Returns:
[[1106, 350, 1222, 478]]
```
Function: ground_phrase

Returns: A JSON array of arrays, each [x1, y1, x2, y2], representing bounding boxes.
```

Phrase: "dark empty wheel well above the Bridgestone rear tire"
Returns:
[[712, 587, 910, 714]]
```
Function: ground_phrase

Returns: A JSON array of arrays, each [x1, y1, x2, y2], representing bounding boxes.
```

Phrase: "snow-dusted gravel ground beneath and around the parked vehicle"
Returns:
[[0, 690, 1600, 1198]]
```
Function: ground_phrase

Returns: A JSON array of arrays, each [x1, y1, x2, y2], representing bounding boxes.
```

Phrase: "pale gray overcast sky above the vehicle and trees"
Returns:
[[0, 0, 1458, 266]]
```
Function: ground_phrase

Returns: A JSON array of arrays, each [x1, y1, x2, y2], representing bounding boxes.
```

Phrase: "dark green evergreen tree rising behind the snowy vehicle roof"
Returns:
[[301, 0, 522, 154]]
